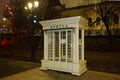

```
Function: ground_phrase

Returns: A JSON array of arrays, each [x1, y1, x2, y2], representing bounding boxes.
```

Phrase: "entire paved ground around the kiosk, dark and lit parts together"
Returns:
[[0, 58, 120, 80]]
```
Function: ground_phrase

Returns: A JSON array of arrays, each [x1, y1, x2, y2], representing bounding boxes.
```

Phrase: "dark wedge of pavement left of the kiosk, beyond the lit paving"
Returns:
[[0, 58, 40, 78]]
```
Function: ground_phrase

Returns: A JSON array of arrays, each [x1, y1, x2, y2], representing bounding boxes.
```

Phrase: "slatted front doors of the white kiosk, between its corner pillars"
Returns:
[[47, 29, 73, 69]]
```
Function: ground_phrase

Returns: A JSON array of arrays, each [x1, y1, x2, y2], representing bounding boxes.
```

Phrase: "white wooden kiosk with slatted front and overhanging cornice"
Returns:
[[40, 16, 87, 75]]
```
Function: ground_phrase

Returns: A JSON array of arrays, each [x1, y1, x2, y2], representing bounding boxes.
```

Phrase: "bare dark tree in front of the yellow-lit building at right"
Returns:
[[92, 0, 120, 36]]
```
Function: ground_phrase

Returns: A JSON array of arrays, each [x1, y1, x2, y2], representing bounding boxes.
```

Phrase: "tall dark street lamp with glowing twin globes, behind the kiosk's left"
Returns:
[[27, 1, 39, 60]]
